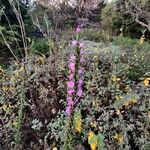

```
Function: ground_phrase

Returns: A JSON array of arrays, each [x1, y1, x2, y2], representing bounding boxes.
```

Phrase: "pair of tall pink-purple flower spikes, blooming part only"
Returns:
[[66, 27, 84, 116]]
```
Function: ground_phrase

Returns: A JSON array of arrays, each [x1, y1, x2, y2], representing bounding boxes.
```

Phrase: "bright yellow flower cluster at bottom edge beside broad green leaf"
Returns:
[[88, 131, 98, 150]]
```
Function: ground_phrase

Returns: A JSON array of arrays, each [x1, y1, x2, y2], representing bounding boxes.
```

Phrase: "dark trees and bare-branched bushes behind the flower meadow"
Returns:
[[0, 0, 150, 63]]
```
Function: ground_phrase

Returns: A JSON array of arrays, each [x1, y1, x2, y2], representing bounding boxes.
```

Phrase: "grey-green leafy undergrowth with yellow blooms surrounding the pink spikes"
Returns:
[[1, 28, 150, 150]]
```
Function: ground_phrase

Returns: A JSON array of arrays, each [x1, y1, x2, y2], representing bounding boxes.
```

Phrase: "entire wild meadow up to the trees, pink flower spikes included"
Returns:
[[0, 1, 150, 150]]
